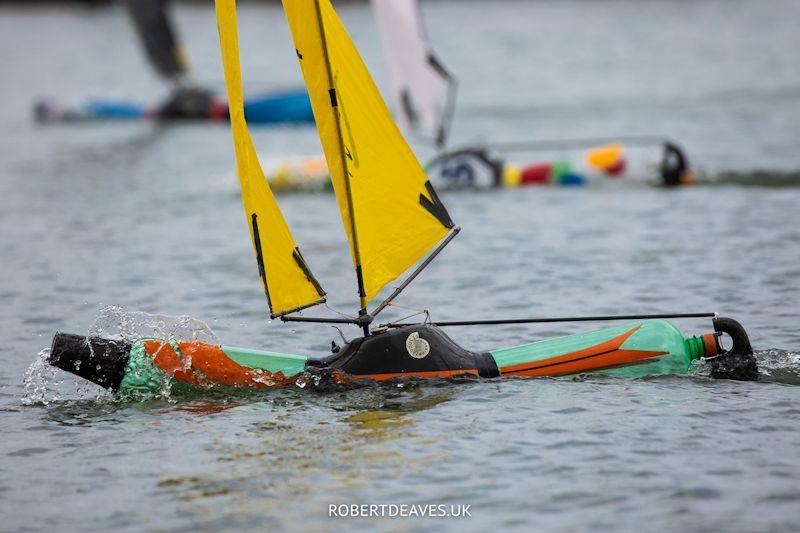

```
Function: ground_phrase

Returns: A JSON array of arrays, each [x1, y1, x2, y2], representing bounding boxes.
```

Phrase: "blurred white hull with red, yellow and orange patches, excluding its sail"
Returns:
[[262, 138, 694, 192]]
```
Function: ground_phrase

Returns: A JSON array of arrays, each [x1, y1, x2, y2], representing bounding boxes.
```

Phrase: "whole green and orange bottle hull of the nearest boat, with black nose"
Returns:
[[50, 320, 752, 400]]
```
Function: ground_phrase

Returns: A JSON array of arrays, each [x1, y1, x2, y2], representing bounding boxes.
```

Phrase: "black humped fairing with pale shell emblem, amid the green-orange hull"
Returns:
[[320, 324, 499, 377]]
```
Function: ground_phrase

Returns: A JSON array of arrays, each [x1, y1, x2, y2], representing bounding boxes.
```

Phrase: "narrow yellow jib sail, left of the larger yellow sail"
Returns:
[[216, 0, 325, 317]]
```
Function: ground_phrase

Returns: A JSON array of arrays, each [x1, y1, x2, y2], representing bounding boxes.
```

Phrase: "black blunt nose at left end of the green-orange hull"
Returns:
[[47, 333, 131, 391]]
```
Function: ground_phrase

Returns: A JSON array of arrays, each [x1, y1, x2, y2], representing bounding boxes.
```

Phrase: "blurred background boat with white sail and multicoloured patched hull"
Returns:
[[253, 0, 694, 192]]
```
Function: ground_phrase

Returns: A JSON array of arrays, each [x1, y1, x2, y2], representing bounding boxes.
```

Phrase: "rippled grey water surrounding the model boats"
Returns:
[[0, 0, 800, 531]]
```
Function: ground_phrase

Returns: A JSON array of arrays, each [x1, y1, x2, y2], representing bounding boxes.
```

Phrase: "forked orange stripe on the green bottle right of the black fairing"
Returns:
[[500, 326, 667, 376]]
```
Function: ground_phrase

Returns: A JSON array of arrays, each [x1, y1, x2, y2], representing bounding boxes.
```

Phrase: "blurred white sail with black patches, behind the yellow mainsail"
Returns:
[[372, 0, 455, 146]]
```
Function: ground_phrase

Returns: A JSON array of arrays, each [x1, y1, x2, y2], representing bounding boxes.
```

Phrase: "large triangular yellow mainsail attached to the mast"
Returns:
[[283, 0, 453, 309]]
